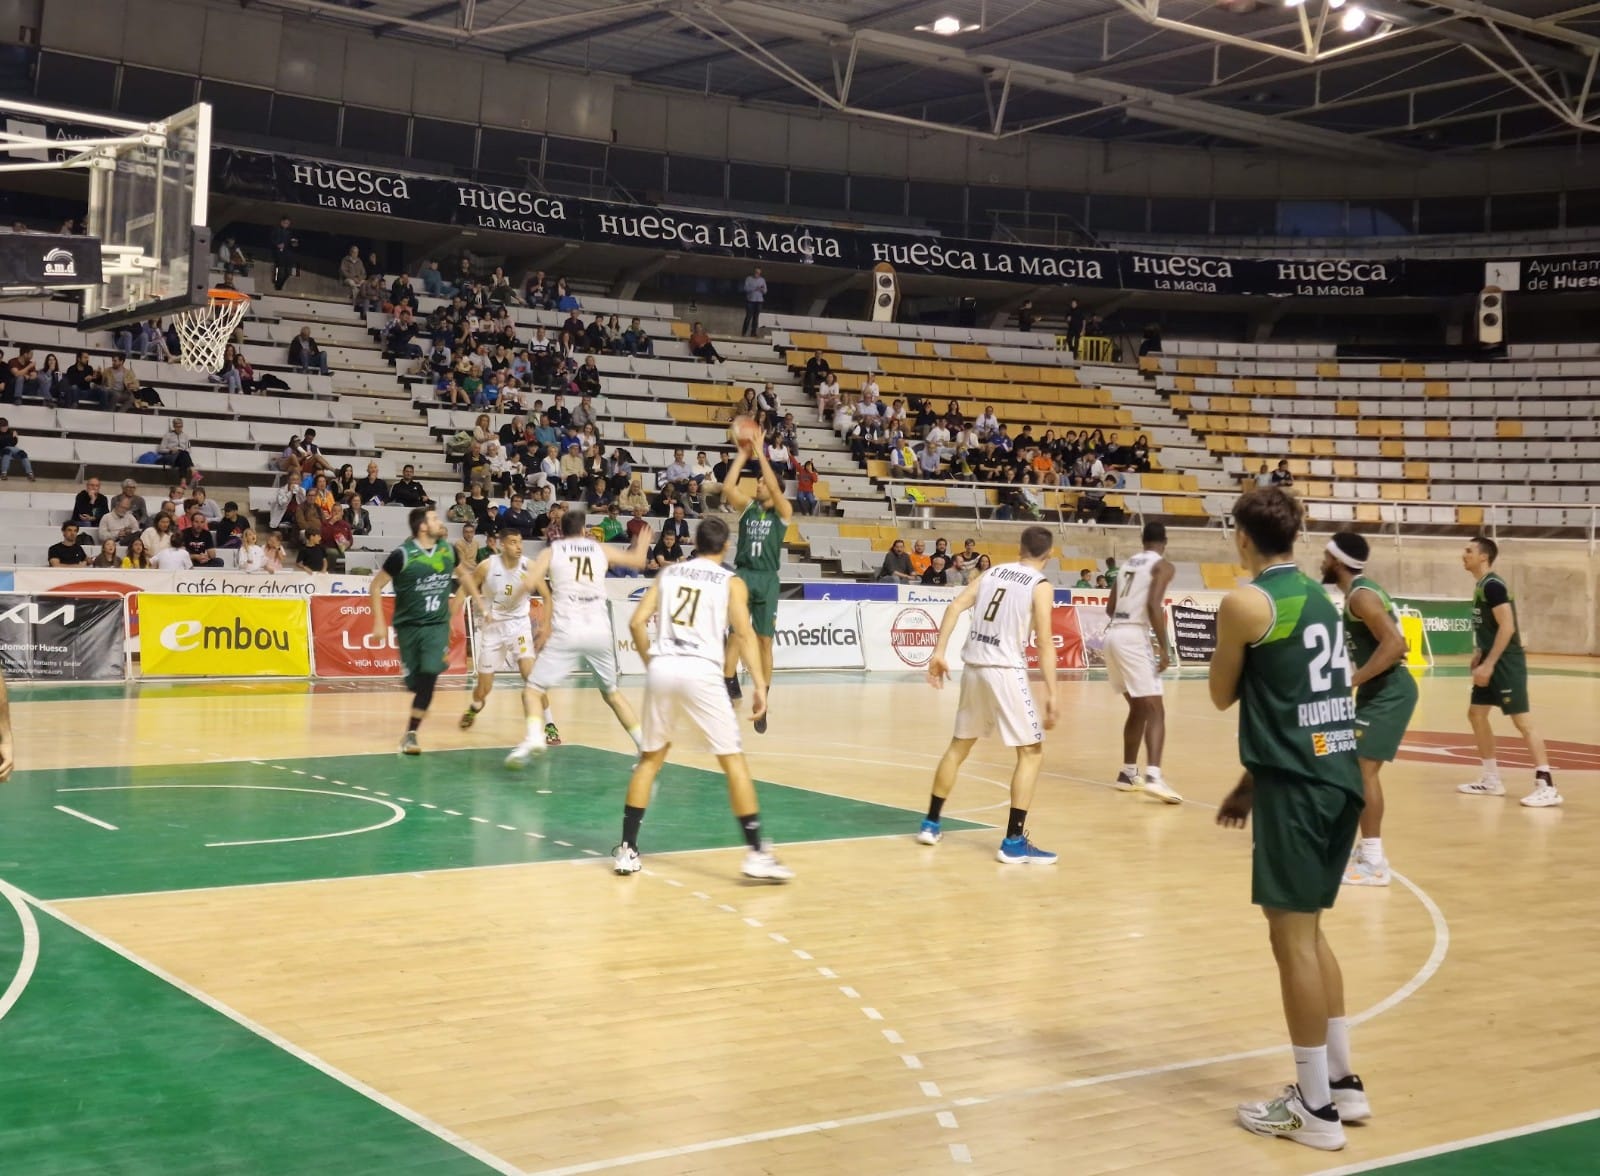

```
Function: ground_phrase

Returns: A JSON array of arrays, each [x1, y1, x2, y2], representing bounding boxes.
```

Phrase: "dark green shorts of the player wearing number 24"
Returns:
[[1250, 773, 1363, 912]]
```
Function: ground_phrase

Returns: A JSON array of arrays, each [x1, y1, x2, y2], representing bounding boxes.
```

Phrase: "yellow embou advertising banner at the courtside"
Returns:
[[138, 592, 310, 678]]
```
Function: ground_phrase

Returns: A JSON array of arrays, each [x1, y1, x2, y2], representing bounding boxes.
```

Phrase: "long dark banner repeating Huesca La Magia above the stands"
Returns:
[[211, 147, 1568, 298]]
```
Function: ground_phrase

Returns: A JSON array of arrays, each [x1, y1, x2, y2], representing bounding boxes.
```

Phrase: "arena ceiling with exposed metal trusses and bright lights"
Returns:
[[246, 0, 1600, 160]]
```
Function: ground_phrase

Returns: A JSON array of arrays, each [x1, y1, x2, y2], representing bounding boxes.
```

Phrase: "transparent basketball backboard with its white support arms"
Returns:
[[0, 101, 211, 331]]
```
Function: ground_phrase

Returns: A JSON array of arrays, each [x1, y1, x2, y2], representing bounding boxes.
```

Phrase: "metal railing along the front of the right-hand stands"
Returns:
[[880, 475, 1600, 554]]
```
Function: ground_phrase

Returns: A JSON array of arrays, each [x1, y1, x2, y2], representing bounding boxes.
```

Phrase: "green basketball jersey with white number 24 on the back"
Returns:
[[1238, 563, 1362, 794]]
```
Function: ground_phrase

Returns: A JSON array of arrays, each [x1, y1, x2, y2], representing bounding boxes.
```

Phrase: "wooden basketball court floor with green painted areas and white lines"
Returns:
[[0, 659, 1600, 1176]]
